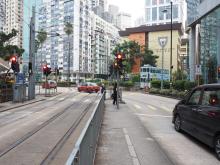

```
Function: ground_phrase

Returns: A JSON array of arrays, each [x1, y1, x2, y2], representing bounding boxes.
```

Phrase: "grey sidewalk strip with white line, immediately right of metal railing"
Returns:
[[95, 100, 173, 165]]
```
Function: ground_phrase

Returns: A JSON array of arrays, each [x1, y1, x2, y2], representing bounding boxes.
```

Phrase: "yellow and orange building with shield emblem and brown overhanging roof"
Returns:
[[119, 23, 182, 74]]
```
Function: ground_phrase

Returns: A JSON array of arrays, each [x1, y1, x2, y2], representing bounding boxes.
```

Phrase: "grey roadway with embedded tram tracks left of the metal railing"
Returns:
[[0, 89, 100, 165]]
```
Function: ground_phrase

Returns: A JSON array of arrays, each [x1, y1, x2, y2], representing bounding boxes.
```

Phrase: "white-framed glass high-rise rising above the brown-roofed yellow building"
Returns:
[[145, 0, 185, 26]]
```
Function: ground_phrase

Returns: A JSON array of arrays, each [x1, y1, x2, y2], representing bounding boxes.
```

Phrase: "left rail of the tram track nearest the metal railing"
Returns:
[[0, 94, 92, 157]]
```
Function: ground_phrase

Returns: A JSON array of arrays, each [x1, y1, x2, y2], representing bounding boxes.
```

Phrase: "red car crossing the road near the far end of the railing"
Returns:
[[78, 82, 100, 93]]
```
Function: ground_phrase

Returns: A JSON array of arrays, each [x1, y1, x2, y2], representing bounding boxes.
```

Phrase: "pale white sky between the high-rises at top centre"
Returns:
[[107, 0, 145, 24]]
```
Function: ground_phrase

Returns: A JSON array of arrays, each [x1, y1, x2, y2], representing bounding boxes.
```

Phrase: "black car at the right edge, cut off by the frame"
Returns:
[[172, 84, 220, 160]]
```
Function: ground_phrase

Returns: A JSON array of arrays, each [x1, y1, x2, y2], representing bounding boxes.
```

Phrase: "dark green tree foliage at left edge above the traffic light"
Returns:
[[0, 29, 24, 61]]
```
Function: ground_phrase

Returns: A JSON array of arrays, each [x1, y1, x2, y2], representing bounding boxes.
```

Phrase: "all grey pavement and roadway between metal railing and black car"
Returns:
[[96, 92, 219, 165]]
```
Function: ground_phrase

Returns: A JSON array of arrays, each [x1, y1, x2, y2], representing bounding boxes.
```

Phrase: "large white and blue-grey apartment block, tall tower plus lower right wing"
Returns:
[[36, 0, 118, 82]]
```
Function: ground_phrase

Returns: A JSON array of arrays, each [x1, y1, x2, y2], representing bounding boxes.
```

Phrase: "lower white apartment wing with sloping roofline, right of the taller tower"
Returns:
[[91, 13, 120, 78]]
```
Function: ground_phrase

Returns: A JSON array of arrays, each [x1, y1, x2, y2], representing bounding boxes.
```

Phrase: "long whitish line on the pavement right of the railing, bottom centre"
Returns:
[[123, 128, 140, 165]]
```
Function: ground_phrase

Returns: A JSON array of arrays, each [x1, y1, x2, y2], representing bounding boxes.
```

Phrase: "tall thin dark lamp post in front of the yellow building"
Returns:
[[170, 1, 173, 82]]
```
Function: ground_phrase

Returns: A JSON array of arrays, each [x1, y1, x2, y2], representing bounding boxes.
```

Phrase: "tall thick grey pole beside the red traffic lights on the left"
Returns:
[[28, 7, 35, 100]]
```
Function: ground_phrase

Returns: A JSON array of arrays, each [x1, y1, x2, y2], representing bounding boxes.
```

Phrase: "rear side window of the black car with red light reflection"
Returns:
[[202, 88, 220, 107]]
